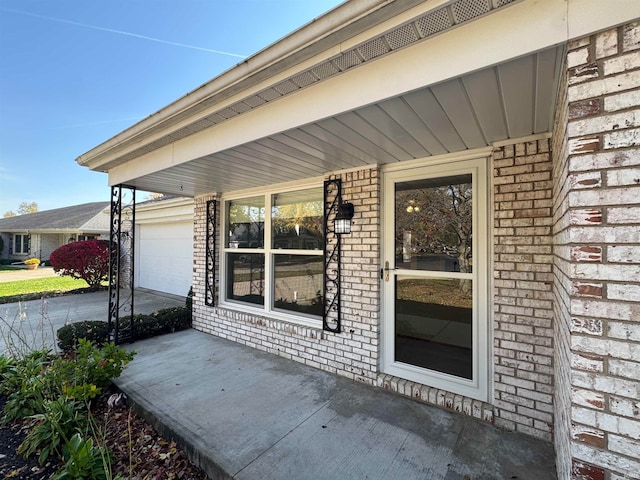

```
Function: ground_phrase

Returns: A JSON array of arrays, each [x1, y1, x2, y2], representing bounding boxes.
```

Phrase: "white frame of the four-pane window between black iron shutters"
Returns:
[[219, 180, 324, 328]]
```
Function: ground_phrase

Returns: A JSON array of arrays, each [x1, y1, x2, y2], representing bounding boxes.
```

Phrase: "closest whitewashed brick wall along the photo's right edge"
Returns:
[[554, 23, 640, 480]]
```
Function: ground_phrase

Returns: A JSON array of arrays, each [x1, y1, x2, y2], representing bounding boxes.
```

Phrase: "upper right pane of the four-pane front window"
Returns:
[[271, 188, 323, 250]]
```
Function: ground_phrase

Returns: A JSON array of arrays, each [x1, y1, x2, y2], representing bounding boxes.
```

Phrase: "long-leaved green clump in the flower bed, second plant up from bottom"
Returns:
[[18, 397, 88, 465]]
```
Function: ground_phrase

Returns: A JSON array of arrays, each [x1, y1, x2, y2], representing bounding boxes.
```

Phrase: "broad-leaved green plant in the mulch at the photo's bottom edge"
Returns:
[[52, 433, 110, 480]]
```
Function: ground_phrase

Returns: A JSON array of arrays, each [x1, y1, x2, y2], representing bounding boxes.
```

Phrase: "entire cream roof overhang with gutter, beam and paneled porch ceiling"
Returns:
[[78, 0, 640, 196]]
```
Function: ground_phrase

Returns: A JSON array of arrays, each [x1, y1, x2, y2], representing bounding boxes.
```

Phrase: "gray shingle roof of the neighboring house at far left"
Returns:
[[0, 202, 109, 232]]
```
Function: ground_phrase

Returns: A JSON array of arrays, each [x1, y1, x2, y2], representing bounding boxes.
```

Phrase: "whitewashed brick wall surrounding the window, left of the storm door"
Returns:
[[193, 169, 380, 384]]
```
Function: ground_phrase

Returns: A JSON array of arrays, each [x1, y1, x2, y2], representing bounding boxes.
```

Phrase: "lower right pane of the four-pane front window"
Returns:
[[273, 255, 324, 316]]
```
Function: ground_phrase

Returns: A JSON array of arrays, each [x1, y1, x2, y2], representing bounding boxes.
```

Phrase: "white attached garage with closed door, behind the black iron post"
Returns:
[[135, 198, 193, 297]]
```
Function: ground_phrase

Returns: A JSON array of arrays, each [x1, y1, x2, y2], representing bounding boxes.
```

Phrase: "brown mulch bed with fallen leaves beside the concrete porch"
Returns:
[[0, 396, 208, 480]]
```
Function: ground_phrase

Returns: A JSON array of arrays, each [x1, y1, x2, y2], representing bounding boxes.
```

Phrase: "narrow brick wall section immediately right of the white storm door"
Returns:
[[493, 139, 554, 441]]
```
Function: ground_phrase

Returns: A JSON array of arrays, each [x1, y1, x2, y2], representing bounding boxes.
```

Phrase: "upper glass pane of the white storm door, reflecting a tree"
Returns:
[[395, 174, 473, 273]]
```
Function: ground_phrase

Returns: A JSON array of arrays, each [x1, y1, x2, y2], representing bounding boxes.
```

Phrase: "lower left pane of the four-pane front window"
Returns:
[[227, 253, 264, 305]]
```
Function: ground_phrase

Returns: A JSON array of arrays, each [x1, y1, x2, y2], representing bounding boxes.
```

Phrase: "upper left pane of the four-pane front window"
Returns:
[[226, 197, 265, 248]]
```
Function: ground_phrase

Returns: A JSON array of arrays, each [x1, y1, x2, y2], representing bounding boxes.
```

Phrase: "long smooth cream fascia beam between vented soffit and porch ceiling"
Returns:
[[109, 0, 566, 185]]
